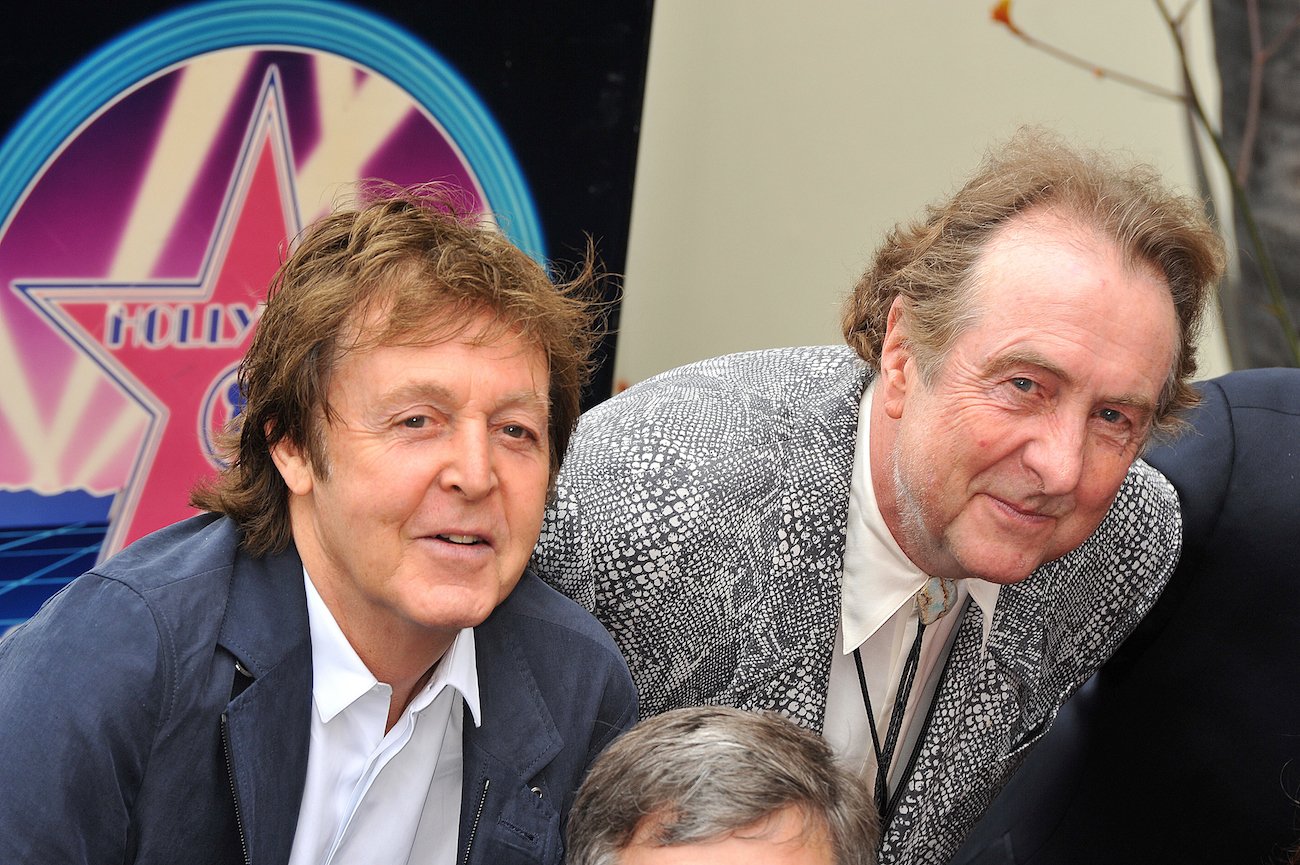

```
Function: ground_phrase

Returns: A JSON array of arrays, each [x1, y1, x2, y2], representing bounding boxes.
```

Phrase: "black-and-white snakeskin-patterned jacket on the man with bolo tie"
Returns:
[[534, 346, 1180, 865]]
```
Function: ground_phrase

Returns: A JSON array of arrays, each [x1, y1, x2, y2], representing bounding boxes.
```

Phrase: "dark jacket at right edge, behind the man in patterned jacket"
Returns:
[[952, 369, 1300, 865]]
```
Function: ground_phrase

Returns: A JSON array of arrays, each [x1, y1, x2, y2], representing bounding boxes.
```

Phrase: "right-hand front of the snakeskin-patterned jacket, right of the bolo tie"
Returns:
[[880, 462, 1180, 865]]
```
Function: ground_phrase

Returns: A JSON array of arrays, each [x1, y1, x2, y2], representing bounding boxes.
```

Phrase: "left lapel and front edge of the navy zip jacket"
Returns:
[[217, 548, 312, 862]]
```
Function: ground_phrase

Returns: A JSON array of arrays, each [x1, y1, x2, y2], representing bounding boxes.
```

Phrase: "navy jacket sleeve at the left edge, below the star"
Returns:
[[0, 574, 168, 865]]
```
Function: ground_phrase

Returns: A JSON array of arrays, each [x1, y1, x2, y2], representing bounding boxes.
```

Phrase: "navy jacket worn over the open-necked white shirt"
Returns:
[[0, 515, 636, 865]]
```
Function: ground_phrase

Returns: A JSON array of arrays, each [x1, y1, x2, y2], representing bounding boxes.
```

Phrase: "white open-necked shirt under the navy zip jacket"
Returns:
[[289, 570, 480, 865]]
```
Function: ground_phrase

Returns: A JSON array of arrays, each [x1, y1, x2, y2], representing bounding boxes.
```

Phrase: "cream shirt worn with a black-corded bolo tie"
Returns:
[[824, 382, 1001, 792]]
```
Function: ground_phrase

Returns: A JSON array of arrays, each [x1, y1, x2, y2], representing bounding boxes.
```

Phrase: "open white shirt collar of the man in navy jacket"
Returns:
[[303, 567, 482, 726]]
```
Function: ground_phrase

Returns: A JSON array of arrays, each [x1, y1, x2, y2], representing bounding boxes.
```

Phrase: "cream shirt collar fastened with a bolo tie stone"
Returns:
[[840, 380, 1001, 654]]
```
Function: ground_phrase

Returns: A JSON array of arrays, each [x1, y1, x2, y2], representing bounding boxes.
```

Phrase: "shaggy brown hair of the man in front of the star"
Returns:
[[190, 183, 599, 555]]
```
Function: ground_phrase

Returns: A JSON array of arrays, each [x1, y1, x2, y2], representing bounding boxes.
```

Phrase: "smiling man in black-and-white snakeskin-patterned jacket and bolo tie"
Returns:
[[534, 130, 1223, 864]]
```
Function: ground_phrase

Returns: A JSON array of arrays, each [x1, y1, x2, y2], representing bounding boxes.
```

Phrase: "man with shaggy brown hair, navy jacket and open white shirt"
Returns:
[[0, 189, 636, 865]]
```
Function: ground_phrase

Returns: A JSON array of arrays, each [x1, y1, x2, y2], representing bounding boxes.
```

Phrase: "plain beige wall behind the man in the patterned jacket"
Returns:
[[615, 0, 1227, 382]]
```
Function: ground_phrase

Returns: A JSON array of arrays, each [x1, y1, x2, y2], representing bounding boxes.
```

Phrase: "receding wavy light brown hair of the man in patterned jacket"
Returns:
[[841, 127, 1225, 436]]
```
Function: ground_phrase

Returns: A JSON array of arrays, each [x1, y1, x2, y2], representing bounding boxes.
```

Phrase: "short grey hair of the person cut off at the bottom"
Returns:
[[566, 706, 880, 865]]
